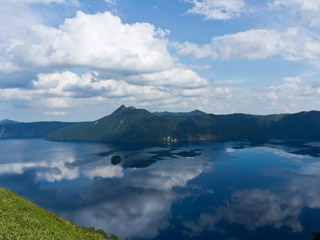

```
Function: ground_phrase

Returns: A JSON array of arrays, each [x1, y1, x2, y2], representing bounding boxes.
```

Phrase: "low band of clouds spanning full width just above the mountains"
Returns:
[[0, 71, 320, 114]]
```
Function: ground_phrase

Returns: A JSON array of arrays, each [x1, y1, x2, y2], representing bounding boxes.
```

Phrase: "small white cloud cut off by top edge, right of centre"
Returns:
[[187, 0, 245, 20]]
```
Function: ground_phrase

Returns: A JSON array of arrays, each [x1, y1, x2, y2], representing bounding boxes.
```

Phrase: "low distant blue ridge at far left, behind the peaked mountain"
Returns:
[[0, 122, 75, 138]]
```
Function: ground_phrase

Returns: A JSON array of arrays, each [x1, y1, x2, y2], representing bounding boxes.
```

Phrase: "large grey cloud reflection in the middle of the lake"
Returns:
[[65, 158, 211, 238]]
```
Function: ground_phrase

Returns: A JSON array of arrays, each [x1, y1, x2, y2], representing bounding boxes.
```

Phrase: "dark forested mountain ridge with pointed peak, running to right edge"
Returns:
[[47, 106, 320, 142]]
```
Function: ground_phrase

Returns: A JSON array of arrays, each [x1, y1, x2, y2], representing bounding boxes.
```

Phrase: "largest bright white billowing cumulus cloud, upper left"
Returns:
[[8, 12, 175, 72]]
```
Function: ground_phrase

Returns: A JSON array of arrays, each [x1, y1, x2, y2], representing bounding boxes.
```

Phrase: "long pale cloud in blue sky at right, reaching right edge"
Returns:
[[176, 28, 320, 65]]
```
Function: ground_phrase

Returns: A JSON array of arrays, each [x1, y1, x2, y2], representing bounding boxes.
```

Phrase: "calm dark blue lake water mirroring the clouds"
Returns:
[[0, 139, 320, 240]]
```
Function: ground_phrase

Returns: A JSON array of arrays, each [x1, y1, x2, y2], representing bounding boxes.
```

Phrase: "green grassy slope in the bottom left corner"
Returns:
[[0, 188, 105, 240]]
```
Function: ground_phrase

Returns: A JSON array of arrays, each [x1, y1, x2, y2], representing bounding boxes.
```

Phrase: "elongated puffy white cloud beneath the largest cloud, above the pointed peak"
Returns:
[[33, 71, 171, 99]]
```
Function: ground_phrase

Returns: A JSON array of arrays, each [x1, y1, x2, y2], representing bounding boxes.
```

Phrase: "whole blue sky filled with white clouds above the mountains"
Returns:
[[0, 0, 320, 122]]
